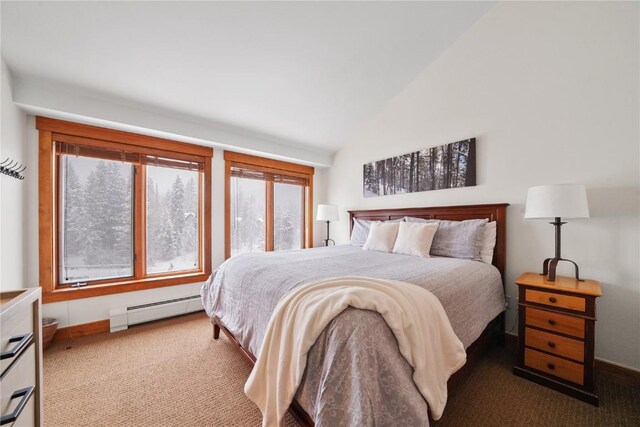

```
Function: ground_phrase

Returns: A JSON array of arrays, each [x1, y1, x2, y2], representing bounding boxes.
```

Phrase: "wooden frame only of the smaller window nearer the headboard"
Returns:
[[224, 151, 314, 259]]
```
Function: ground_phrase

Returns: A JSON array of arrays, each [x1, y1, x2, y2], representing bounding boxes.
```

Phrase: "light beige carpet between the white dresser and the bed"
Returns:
[[44, 312, 296, 427]]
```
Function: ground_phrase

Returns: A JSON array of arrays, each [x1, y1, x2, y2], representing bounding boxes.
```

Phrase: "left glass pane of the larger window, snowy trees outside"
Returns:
[[59, 154, 134, 284]]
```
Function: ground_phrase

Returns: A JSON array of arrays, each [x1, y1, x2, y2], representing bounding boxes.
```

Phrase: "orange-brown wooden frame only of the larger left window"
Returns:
[[36, 117, 213, 303]]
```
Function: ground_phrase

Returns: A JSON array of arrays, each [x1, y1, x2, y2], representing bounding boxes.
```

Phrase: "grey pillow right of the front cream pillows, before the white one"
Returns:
[[431, 219, 487, 260]]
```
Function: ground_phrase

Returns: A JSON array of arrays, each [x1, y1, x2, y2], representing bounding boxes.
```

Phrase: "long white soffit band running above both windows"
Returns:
[[12, 75, 331, 166]]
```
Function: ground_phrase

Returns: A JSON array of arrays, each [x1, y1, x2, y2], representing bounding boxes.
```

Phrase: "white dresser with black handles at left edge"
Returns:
[[0, 288, 42, 427]]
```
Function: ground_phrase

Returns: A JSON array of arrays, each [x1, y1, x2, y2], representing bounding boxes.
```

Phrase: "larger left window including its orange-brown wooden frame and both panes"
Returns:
[[36, 117, 213, 302]]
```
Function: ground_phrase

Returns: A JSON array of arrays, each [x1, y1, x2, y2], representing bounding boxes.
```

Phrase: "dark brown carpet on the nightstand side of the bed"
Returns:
[[436, 347, 640, 427]]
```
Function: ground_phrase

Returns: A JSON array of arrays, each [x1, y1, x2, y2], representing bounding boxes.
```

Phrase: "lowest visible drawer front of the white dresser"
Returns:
[[0, 344, 36, 427]]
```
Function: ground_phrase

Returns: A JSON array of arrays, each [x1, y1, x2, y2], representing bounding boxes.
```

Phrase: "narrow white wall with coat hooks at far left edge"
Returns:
[[0, 59, 28, 291]]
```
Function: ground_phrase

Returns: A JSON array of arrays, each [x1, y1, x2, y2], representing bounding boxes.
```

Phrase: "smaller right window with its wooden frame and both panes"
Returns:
[[225, 151, 313, 258]]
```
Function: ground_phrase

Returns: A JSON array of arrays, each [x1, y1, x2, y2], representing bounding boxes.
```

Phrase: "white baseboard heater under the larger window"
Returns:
[[109, 295, 203, 332]]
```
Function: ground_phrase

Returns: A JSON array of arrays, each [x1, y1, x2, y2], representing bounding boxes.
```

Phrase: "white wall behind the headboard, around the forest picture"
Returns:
[[321, 2, 640, 369]]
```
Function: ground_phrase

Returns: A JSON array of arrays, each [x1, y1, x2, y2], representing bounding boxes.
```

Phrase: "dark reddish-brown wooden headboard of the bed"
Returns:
[[349, 203, 509, 281]]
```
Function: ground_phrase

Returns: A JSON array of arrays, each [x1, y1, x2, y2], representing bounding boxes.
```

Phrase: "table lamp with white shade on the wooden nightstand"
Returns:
[[524, 184, 589, 282]]
